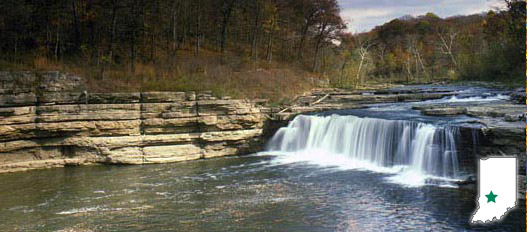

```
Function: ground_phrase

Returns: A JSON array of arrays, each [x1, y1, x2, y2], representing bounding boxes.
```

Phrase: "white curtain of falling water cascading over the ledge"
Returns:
[[268, 115, 459, 186]]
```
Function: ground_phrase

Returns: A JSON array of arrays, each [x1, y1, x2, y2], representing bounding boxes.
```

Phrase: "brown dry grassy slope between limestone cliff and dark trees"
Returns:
[[0, 50, 316, 103]]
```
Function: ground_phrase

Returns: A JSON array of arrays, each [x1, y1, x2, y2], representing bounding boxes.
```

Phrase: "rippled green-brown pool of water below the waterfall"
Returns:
[[0, 155, 525, 231]]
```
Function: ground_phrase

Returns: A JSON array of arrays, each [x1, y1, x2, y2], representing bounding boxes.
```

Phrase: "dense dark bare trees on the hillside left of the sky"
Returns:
[[0, 0, 344, 71]]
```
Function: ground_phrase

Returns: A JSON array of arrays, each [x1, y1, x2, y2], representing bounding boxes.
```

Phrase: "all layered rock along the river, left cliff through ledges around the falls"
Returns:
[[0, 72, 525, 196]]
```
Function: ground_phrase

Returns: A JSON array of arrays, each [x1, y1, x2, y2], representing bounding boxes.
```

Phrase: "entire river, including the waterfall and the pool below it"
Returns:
[[0, 85, 526, 231]]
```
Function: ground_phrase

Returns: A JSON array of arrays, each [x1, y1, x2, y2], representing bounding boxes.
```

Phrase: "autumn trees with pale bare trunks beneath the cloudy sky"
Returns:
[[332, 0, 526, 87]]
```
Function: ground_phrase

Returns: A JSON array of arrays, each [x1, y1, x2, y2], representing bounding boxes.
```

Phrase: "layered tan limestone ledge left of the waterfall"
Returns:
[[0, 72, 265, 173]]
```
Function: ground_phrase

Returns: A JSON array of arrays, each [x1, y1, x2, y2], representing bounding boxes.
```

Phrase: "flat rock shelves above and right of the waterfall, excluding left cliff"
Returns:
[[274, 86, 527, 199]]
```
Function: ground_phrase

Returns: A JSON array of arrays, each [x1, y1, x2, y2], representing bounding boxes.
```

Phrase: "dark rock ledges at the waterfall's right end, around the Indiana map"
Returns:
[[413, 100, 527, 199]]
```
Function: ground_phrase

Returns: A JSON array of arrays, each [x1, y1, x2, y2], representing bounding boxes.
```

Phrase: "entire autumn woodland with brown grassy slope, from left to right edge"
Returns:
[[0, 0, 526, 100]]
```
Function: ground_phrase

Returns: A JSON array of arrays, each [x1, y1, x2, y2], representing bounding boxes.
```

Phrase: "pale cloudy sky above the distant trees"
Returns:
[[339, 0, 503, 33]]
